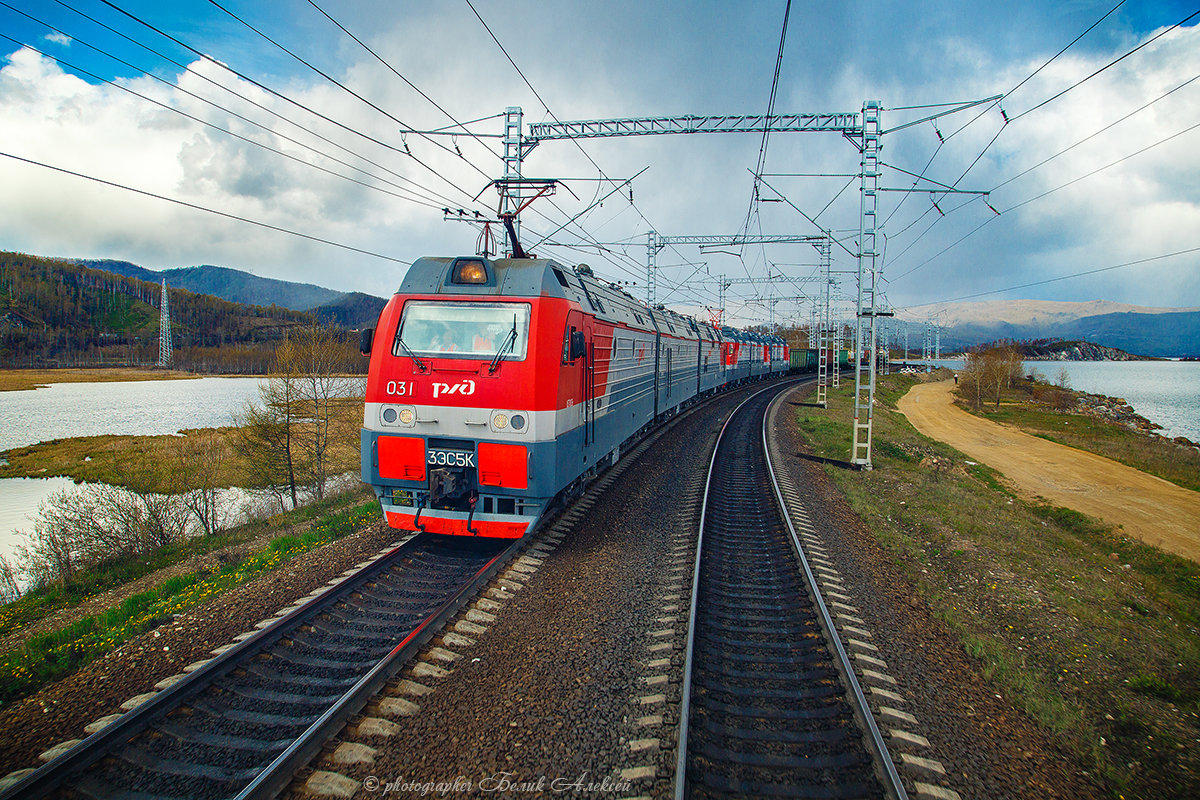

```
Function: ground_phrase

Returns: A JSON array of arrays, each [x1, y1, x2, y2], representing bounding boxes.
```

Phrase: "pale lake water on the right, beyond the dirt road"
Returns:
[[916, 361, 1200, 441]]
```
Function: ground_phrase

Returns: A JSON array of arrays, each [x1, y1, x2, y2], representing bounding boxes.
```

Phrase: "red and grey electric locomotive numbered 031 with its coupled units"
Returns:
[[361, 255, 788, 539]]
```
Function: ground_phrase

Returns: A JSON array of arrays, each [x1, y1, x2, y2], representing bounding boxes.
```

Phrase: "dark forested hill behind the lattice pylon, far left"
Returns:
[[0, 252, 324, 373]]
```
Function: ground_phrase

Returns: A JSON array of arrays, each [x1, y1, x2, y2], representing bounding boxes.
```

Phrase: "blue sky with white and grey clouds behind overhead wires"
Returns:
[[0, 0, 1200, 324]]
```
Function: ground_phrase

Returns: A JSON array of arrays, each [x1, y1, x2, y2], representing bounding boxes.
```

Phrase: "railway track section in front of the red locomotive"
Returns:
[[0, 534, 523, 800]]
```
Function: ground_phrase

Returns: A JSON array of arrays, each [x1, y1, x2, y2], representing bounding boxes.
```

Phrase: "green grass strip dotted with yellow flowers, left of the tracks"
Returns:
[[0, 498, 379, 706]]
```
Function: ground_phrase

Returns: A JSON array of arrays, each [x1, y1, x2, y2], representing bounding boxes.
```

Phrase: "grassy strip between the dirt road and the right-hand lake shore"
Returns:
[[960, 384, 1200, 492]]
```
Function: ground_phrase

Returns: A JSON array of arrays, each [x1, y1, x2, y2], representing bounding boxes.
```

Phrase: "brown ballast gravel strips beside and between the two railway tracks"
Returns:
[[0, 390, 1100, 800]]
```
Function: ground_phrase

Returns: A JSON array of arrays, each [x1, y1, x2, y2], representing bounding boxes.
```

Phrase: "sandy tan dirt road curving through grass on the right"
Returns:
[[898, 380, 1200, 561]]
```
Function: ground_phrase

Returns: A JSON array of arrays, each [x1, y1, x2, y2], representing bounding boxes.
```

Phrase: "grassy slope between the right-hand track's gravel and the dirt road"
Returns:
[[797, 375, 1200, 799]]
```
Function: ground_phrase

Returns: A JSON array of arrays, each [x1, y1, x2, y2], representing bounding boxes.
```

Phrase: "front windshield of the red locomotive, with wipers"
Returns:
[[392, 300, 529, 361]]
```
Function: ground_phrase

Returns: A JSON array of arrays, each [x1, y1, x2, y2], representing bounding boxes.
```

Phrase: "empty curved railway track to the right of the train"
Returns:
[[676, 383, 907, 800]]
